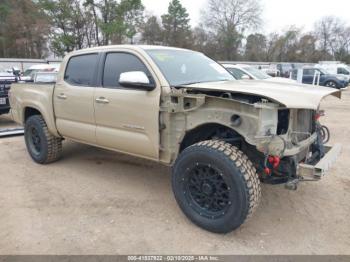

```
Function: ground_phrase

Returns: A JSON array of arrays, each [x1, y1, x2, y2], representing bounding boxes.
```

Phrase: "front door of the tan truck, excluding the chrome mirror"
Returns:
[[94, 52, 160, 159]]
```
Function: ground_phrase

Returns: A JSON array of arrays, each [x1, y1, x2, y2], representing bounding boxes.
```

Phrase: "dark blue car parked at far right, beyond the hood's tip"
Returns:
[[292, 67, 349, 89]]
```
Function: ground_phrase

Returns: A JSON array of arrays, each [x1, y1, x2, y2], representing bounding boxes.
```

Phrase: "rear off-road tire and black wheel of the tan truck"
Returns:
[[24, 115, 62, 164]]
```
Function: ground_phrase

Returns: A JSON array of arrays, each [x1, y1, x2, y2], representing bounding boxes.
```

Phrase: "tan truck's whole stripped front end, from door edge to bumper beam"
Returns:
[[161, 84, 340, 189]]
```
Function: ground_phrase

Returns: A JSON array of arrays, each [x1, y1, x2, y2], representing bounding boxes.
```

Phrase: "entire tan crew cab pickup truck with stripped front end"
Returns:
[[10, 46, 341, 233]]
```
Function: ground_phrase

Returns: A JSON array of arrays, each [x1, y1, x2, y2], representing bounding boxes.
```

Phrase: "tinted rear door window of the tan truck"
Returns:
[[64, 54, 98, 87]]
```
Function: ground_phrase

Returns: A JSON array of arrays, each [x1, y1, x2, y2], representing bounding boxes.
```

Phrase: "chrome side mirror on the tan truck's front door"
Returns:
[[119, 71, 156, 91]]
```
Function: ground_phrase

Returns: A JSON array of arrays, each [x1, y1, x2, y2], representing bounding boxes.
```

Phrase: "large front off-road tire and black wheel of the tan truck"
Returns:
[[172, 140, 261, 233]]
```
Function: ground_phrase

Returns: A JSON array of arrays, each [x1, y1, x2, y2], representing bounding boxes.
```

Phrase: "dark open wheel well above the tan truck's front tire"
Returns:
[[180, 123, 243, 152]]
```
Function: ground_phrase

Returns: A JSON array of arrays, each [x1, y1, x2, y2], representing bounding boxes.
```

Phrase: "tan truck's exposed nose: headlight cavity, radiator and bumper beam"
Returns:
[[252, 104, 341, 190]]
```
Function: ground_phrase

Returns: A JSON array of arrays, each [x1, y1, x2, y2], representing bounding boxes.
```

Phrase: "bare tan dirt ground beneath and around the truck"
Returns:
[[0, 92, 350, 254]]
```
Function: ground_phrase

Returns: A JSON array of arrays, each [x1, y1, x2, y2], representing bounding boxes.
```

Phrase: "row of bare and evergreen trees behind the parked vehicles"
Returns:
[[0, 0, 350, 63]]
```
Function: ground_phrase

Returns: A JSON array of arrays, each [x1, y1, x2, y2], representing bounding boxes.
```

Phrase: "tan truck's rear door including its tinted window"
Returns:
[[53, 53, 99, 144]]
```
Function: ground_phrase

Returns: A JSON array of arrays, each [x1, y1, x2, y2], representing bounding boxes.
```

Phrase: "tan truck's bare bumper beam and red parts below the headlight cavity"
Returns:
[[257, 132, 342, 190]]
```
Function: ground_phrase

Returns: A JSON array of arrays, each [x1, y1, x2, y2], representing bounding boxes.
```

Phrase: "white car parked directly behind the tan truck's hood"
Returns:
[[223, 64, 296, 84]]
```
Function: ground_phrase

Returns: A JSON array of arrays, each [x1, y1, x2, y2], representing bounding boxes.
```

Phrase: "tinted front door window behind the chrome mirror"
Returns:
[[103, 53, 154, 88]]
